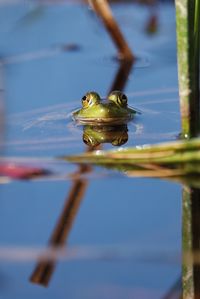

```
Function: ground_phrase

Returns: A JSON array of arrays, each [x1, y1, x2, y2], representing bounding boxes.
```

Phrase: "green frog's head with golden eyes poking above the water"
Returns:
[[73, 91, 136, 125]]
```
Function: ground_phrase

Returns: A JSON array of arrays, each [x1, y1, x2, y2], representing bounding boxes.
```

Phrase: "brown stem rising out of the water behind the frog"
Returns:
[[89, 0, 134, 61]]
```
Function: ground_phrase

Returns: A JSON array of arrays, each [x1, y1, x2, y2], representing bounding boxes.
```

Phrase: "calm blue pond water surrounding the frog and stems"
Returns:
[[0, 1, 182, 299]]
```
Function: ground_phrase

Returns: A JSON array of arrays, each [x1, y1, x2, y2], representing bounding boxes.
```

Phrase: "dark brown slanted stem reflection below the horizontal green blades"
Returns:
[[30, 165, 90, 286]]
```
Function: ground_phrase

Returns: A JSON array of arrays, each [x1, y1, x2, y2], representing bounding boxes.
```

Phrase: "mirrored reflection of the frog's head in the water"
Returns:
[[83, 125, 128, 147]]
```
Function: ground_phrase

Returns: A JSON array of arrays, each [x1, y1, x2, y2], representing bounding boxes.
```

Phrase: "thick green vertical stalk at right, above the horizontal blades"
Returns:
[[175, 0, 200, 137]]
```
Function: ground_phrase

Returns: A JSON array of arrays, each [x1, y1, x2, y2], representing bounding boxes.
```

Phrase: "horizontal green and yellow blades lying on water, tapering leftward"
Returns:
[[61, 138, 200, 177]]
